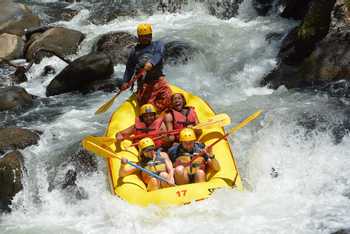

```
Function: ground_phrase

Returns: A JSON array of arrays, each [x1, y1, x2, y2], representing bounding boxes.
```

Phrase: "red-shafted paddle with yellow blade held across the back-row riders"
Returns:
[[91, 113, 231, 144]]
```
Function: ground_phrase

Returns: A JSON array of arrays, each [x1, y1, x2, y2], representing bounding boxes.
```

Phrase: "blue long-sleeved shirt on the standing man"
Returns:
[[123, 41, 165, 82]]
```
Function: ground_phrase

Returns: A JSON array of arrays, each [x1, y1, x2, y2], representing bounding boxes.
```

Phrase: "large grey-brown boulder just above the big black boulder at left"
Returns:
[[26, 28, 85, 63]]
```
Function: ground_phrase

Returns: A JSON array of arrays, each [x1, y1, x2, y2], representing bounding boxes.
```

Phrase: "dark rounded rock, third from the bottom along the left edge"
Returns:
[[0, 86, 33, 111]]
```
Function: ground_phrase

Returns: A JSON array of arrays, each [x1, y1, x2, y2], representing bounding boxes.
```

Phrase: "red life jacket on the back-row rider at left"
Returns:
[[135, 116, 163, 148]]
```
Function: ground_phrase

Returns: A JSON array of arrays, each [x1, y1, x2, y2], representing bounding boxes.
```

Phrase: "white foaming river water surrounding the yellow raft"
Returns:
[[0, 0, 350, 234]]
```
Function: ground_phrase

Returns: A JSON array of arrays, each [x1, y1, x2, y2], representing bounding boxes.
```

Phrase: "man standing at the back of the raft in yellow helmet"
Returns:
[[120, 24, 171, 112]]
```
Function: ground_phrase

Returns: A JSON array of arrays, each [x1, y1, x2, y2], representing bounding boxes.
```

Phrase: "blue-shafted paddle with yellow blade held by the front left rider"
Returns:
[[83, 136, 175, 186]]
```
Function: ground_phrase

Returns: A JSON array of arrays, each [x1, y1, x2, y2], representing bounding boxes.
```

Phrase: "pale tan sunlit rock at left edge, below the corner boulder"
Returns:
[[0, 33, 24, 60]]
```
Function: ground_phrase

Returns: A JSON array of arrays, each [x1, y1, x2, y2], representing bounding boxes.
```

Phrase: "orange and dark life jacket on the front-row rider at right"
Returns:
[[172, 143, 207, 174]]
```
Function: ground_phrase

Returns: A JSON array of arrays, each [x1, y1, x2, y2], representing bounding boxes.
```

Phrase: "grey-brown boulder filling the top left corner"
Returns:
[[0, 0, 40, 36]]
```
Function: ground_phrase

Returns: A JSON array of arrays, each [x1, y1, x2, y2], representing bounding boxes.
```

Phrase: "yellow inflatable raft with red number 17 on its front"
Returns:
[[83, 86, 243, 206]]
